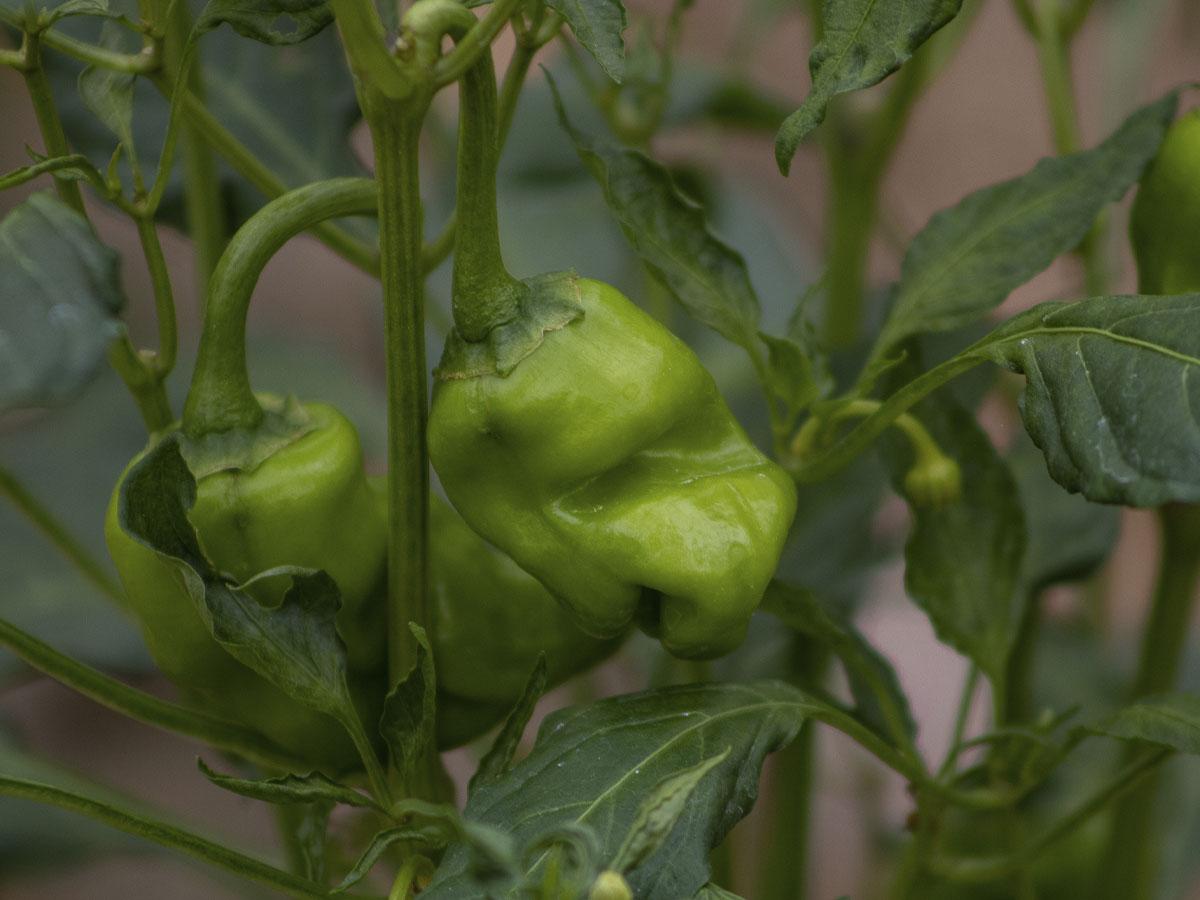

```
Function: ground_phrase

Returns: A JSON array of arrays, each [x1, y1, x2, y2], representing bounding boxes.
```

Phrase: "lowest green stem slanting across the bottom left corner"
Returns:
[[0, 775, 360, 899]]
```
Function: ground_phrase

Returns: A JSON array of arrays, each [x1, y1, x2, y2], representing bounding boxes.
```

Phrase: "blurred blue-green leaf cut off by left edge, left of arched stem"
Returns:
[[0, 193, 124, 412]]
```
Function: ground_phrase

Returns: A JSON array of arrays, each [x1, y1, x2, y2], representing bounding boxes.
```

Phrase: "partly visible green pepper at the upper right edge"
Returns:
[[1129, 109, 1200, 294]]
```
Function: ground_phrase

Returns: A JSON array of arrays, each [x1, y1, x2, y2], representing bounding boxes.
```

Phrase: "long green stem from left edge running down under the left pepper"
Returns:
[[0, 619, 314, 772]]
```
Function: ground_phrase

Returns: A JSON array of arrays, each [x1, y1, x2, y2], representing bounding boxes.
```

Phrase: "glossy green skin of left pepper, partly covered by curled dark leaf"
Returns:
[[104, 403, 386, 767]]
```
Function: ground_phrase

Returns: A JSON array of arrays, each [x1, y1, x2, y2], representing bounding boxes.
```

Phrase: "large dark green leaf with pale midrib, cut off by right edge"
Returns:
[[965, 294, 1200, 506]]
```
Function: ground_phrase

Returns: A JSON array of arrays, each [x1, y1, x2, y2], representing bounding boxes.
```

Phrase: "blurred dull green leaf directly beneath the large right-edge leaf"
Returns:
[[1007, 436, 1121, 592]]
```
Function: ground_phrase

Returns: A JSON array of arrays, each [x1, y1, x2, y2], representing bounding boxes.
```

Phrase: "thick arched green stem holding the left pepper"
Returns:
[[184, 178, 379, 437]]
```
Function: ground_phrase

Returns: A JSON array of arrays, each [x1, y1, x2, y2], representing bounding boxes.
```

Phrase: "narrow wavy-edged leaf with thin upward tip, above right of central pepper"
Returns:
[[547, 74, 761, 355]]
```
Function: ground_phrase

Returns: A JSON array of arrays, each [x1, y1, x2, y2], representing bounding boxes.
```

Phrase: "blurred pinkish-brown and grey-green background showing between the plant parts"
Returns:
[[0, 0, 1200, 900]]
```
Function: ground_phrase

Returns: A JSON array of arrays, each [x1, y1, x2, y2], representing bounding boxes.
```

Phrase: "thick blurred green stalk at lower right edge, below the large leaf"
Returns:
[[1097, 504, 1200, 900]]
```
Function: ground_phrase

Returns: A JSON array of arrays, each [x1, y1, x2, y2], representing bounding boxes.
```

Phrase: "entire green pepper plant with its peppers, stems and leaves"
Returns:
[[0, 0, 1200, 900]]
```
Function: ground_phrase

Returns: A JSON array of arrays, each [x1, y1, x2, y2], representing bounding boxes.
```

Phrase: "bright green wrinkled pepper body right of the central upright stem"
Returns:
[[428, 276, 796, 659]]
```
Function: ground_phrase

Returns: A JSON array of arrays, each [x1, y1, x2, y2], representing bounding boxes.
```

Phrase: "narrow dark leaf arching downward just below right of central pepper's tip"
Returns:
[[762, 578, 917, 742]]
